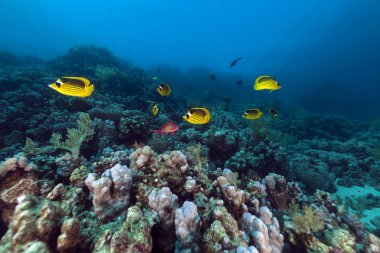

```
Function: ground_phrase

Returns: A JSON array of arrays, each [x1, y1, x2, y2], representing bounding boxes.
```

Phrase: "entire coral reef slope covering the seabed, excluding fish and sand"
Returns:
[[0, 45, 380, 253]]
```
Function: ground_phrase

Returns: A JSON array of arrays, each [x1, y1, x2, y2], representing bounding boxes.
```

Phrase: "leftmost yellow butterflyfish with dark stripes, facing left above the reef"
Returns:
[[49, 76, 95, 98]]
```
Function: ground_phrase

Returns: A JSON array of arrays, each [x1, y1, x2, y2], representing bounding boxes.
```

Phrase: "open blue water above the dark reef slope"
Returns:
[[0, 0, 380, 119]]
